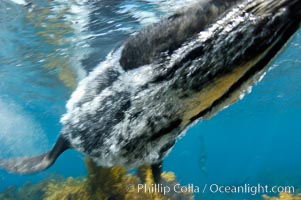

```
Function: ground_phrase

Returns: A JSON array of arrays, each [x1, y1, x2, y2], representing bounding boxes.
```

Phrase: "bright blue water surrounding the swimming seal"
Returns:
[[0, 0, 301, 199]]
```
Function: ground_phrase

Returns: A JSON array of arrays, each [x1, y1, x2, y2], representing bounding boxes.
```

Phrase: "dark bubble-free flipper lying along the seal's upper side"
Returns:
[[120, 0, 240, 70]]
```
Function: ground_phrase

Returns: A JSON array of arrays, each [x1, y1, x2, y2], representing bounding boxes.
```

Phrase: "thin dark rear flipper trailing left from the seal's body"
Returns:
[[0, 136, 69, 174]]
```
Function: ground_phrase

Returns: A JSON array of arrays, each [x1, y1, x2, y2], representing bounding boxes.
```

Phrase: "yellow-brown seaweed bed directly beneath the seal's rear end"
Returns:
[[0, 158, 193, 200]]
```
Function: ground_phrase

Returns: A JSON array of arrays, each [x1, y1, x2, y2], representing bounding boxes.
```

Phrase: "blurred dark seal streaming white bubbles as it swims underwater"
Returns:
[[0, 0, 301, 173]]
